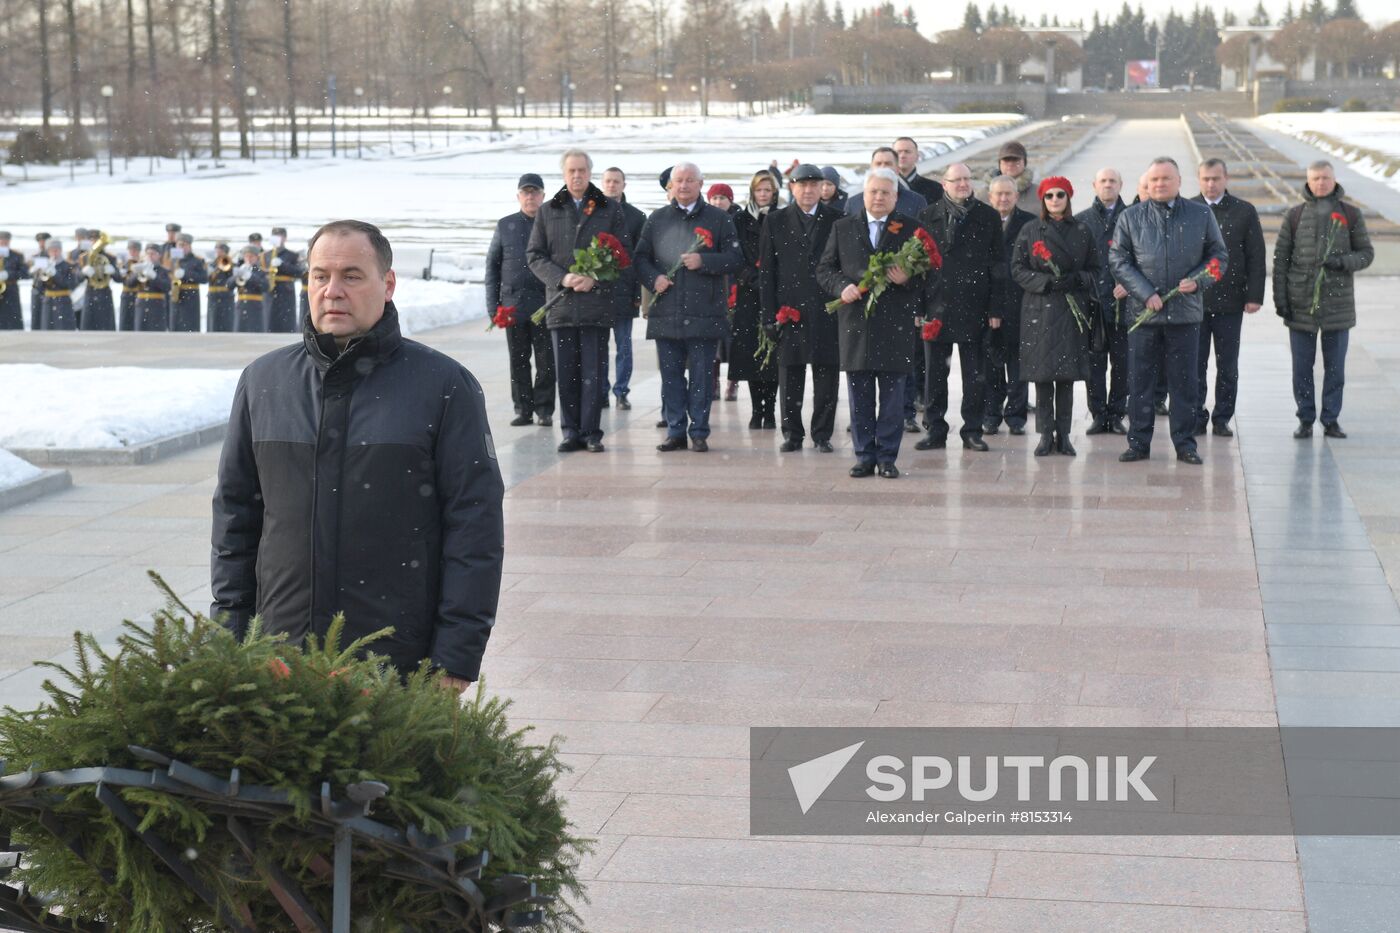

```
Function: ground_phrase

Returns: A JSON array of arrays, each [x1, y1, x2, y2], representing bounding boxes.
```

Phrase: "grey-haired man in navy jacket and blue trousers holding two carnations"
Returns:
[[637, 163, 743, 452]]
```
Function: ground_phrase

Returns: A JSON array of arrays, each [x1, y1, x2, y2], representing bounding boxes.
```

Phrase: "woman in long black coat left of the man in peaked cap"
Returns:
[[729, 170, 778, 429]]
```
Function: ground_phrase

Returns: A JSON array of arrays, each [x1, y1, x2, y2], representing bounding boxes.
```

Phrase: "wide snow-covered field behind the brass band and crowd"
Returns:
[[4, 113, 1025, 267]]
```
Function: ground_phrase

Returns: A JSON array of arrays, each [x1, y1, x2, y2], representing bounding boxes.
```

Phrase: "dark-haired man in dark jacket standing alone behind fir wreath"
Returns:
[[210, 220, 504, 689]]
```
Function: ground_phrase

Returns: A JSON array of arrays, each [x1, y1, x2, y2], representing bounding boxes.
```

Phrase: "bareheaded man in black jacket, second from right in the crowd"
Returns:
[[1194, 158, 1264, 437]]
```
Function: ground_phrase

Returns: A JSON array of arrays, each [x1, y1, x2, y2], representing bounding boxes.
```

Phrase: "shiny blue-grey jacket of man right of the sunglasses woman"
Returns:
[[1109, 195, 1229, 326]]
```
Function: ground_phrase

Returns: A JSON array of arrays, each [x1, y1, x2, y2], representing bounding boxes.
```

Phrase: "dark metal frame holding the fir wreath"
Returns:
[[0, 745, 552, 933]]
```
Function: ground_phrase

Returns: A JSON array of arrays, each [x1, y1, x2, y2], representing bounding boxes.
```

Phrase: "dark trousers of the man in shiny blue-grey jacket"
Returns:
[[1128, 324, 1201, 452]]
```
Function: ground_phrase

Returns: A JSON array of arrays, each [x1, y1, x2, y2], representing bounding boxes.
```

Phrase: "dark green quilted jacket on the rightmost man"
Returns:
[[1274, 185, 1376, 333]]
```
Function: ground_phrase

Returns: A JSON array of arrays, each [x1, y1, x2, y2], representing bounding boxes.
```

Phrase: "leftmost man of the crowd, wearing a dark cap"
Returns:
[[486, 172, 554, 427]]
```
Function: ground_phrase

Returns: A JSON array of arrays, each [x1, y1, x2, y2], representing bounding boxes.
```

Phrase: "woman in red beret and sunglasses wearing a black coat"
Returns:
[[1011, 177, 1099, 457]]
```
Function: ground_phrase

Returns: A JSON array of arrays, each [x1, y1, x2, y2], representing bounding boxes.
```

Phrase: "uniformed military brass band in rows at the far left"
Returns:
[[0, 223, 307, 333]]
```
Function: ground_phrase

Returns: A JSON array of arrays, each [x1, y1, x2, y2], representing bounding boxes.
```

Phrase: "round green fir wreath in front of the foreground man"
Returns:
[[0, 573, 591, 933]]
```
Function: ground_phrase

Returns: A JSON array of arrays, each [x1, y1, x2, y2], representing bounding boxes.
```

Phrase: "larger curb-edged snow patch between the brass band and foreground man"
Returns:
[[0, 363, 238, 448]]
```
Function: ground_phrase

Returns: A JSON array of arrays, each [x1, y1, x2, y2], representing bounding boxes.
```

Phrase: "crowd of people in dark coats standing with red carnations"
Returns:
[[487, 137, 1373, 476]]
